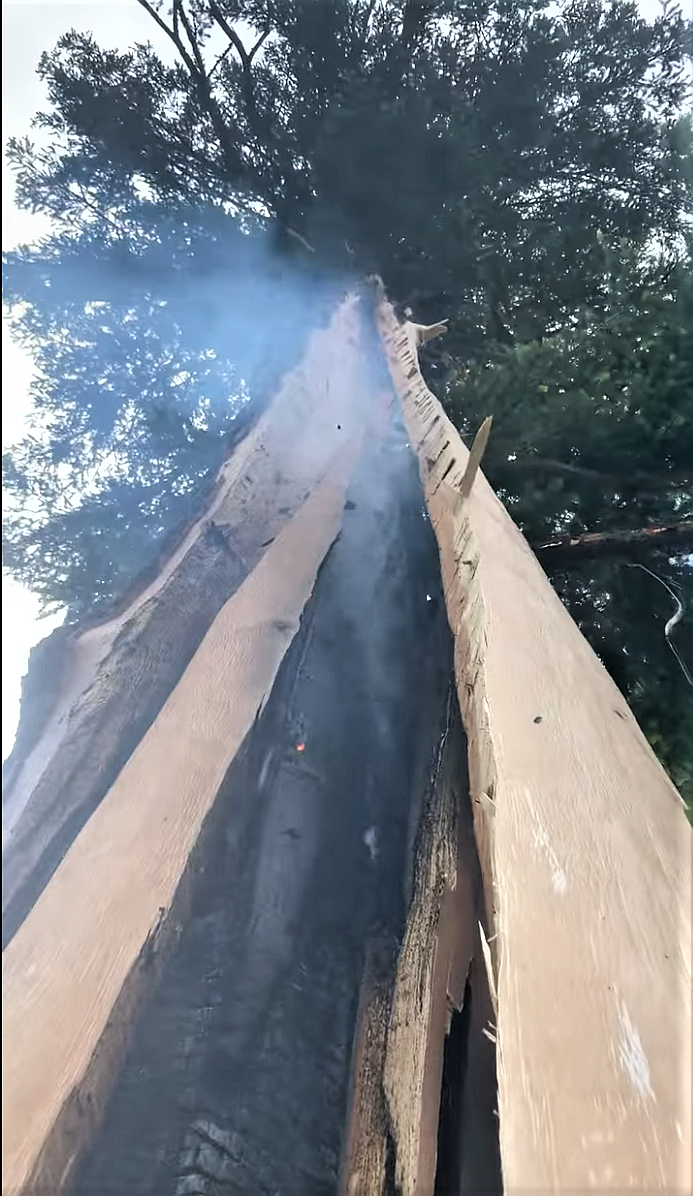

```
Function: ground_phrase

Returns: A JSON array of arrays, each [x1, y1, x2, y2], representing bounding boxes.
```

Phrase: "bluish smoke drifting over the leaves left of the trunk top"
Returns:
[[4, 205, 354, 617]]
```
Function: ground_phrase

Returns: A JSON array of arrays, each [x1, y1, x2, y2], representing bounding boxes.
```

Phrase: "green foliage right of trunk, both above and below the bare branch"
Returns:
[[446, 246, 693, 803]]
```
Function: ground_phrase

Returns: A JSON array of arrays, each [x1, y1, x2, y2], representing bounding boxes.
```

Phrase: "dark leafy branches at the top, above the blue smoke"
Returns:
[[11, 0, 691, 352]]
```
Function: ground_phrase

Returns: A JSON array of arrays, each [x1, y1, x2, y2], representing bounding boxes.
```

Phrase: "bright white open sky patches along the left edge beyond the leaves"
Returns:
[[2, 0, 693, 759]]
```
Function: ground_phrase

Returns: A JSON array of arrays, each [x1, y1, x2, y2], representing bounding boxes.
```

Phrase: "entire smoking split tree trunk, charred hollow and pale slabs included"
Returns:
[[2, 289, 691, 1196]]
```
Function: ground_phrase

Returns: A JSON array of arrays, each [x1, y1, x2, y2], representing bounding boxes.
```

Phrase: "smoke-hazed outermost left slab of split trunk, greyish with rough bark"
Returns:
[[2, 298, 375, 942]]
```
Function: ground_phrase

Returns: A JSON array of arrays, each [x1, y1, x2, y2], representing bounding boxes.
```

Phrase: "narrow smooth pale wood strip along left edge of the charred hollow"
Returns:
[[2, 447, 359, 1196]]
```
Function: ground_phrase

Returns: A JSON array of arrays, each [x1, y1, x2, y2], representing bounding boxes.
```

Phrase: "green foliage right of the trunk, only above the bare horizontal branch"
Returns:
[[445, 245, 693, 542]]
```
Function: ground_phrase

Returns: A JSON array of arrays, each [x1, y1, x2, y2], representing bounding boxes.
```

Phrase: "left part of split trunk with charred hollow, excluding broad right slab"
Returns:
[[2, 301, 498, 1196]]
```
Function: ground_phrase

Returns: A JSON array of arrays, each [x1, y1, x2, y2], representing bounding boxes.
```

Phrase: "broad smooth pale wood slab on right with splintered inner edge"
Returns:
[[379, 294, 692, 1194]]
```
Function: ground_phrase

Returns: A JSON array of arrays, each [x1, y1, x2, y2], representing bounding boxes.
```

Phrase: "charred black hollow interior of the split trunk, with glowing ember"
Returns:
[[65, 413, 495, 1196]]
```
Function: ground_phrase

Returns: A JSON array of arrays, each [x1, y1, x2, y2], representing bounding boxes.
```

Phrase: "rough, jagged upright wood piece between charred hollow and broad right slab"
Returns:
[[339, 692, 485, 1196]]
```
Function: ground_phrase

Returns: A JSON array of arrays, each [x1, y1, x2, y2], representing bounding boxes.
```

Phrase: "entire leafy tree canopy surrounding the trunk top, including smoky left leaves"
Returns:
[[4, 0, 693, 808]]
